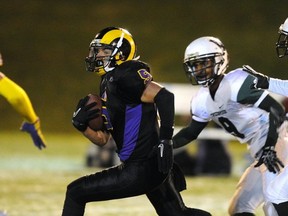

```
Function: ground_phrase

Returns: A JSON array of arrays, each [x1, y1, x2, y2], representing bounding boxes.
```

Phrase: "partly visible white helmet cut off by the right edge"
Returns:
[[276, 18, 288, 58]]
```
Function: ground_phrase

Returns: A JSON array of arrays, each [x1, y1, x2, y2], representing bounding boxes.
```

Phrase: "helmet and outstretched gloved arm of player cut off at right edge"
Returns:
[[248, 18, 288, 94]]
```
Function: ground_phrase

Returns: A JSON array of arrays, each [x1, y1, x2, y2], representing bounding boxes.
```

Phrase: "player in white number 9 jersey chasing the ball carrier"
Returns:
[[173, 37, 288, 216]]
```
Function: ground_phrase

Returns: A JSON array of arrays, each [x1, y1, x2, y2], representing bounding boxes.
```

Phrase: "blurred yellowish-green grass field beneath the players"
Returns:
[[0, 132, 263, 216]]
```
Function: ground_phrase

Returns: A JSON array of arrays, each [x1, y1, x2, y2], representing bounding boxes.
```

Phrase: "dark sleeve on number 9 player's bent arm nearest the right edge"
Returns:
[[259, 95, 285, 146]]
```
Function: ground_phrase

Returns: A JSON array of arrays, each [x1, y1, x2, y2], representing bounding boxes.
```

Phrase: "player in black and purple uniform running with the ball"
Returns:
[[62, 27, 211, 216]]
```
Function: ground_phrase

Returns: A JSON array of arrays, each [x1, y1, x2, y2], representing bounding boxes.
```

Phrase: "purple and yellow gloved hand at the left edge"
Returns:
[[20, 118, 46, 150]]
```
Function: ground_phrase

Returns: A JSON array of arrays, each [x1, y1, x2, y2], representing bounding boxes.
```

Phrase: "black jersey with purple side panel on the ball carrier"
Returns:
[[100, 60, 158, 161]]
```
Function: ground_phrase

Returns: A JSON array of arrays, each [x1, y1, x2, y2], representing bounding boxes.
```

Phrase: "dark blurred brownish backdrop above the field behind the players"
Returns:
[[0, 0, 288, 133]]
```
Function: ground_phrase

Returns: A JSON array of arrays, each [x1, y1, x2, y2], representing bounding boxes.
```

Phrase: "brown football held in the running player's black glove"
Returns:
[[86, 94, 103, 131]]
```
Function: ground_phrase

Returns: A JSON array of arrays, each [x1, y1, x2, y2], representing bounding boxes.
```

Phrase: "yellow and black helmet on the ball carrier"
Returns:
[[85, 27, 136, 76]]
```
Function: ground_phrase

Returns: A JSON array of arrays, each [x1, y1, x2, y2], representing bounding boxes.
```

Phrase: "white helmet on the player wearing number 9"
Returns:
[[184, 36, 229, 87]]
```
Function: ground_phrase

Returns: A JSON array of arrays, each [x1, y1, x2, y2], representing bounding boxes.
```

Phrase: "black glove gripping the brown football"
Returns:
[[72, 96, 101, 132]]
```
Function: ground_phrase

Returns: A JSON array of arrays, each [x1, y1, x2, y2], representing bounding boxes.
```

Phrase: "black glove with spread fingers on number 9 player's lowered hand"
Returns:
[[254, 146, 284, 173]]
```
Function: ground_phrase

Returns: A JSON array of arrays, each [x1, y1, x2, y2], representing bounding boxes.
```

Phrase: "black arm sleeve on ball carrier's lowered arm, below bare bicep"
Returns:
[[154, 88, 175, 140]]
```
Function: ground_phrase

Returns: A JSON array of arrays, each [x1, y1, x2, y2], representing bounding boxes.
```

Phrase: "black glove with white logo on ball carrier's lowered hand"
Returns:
[[157, 140, 173, 174]]
